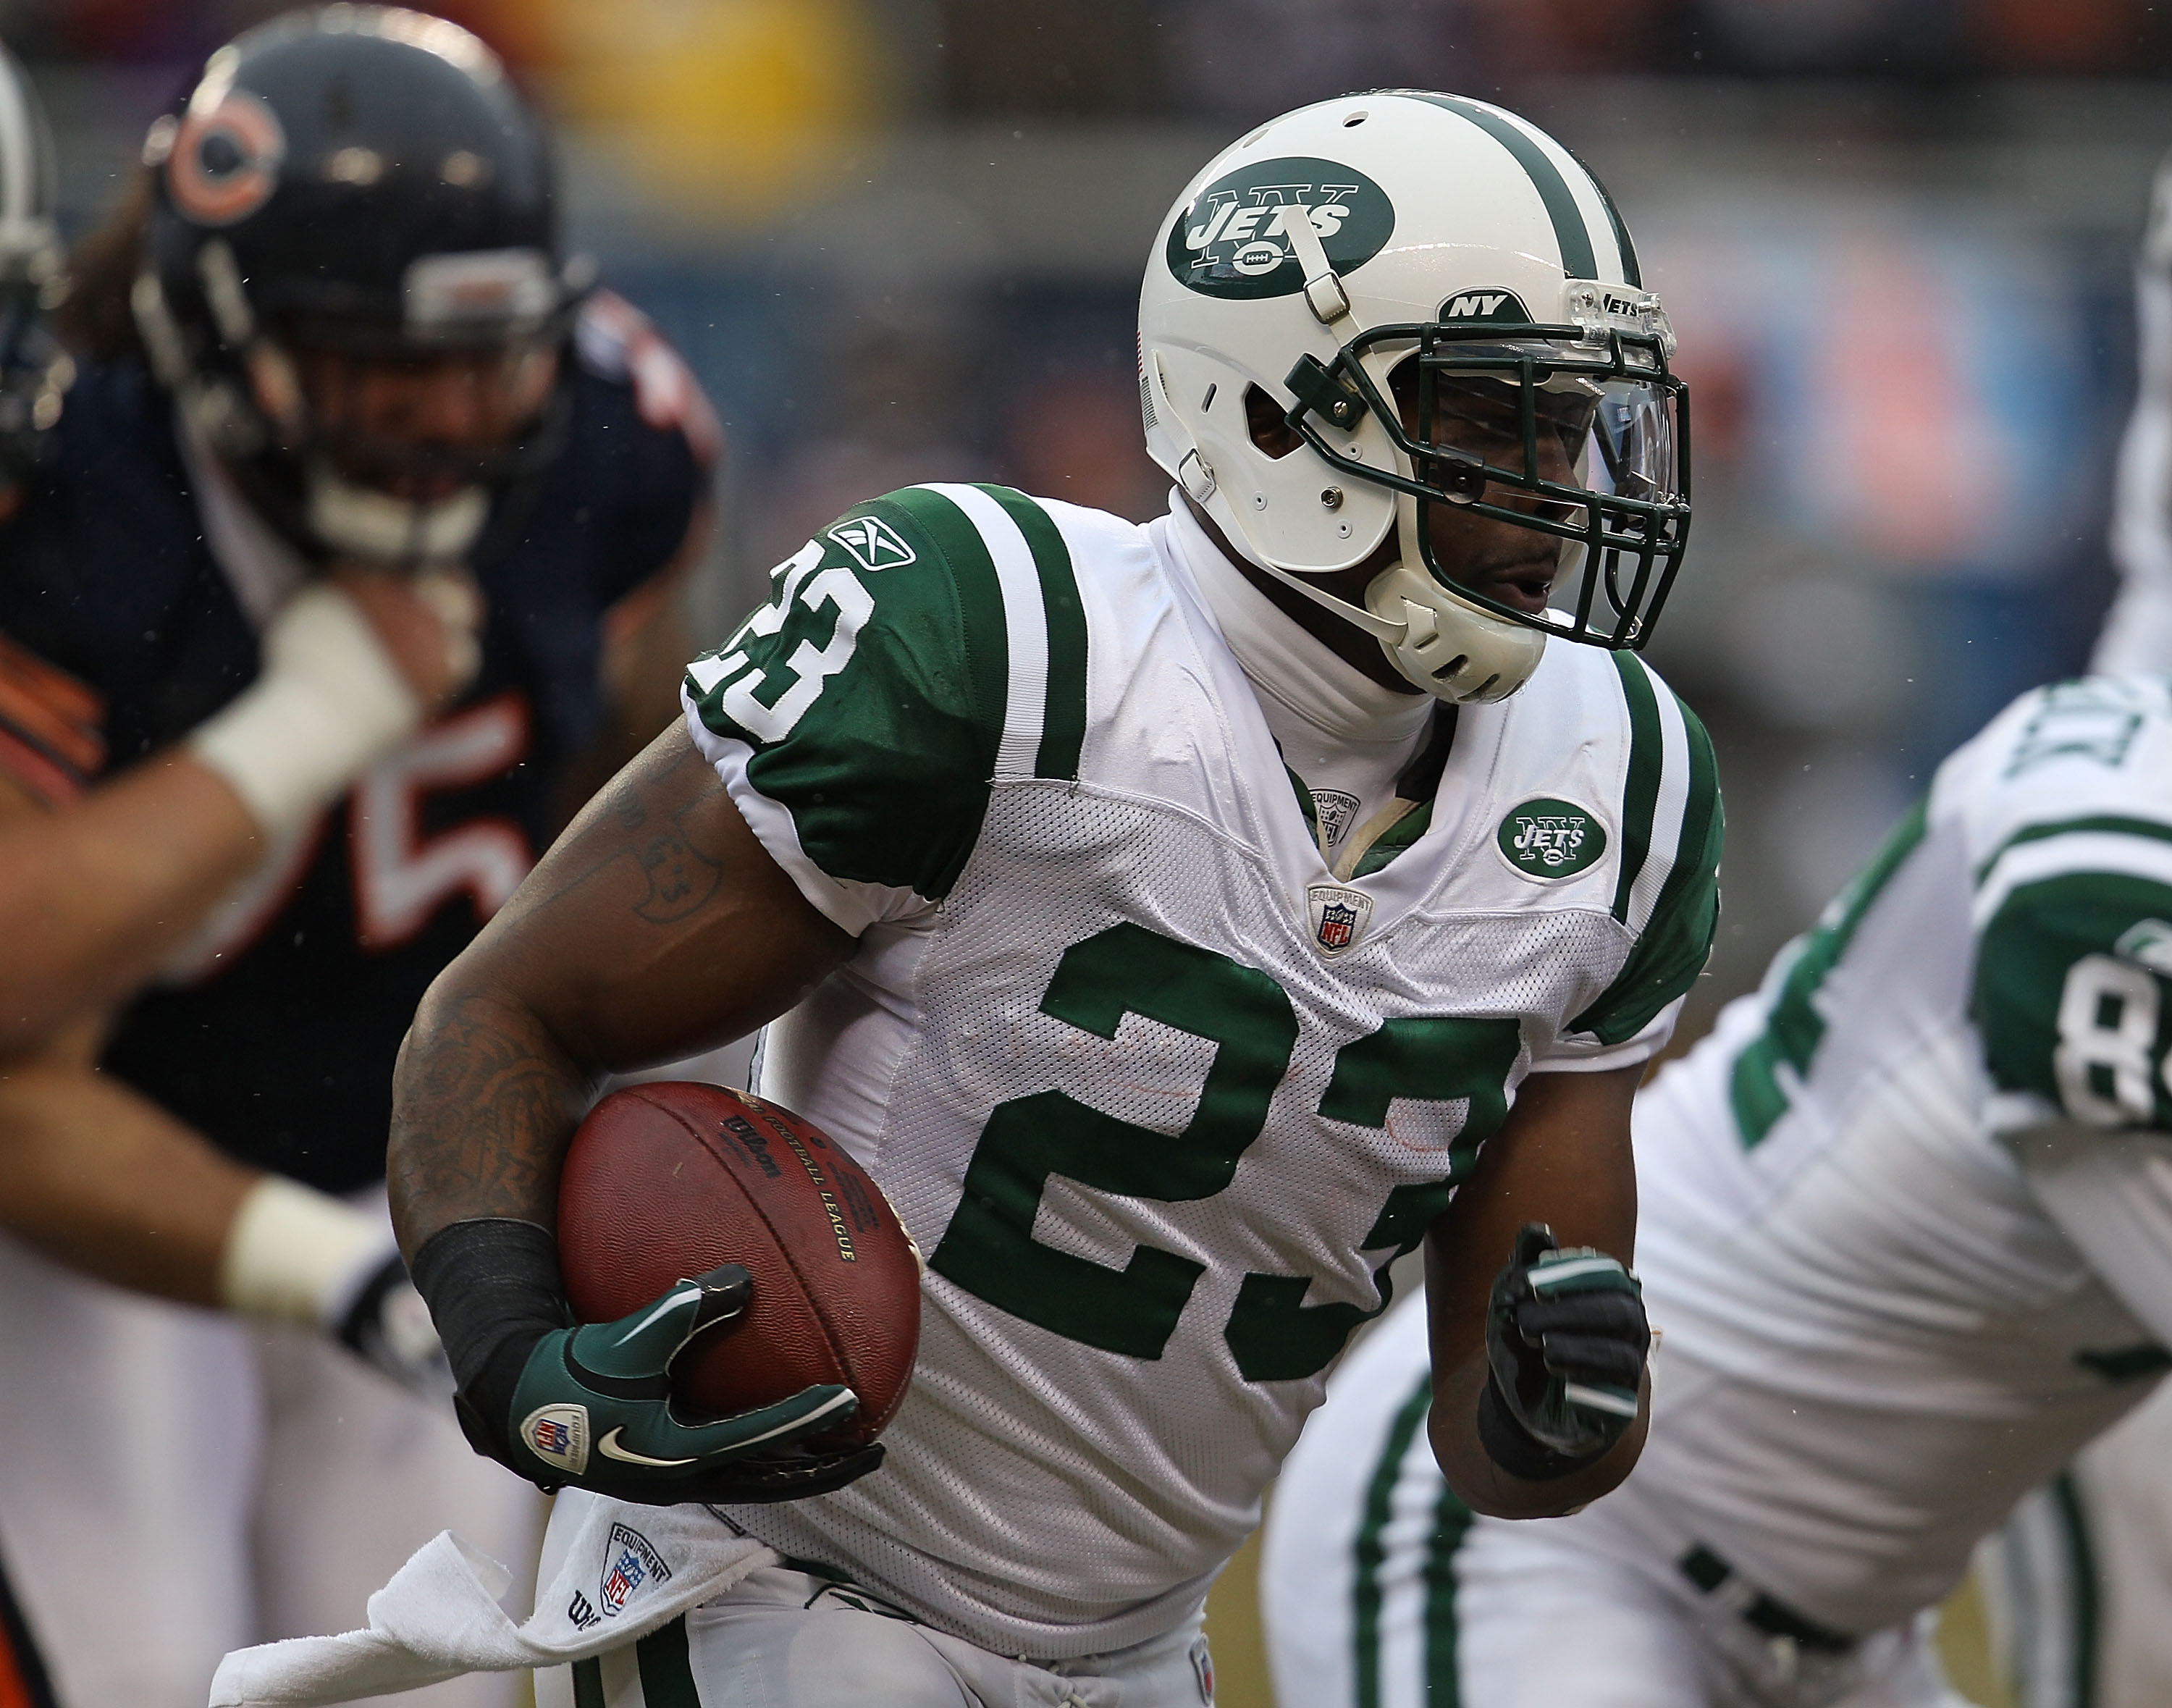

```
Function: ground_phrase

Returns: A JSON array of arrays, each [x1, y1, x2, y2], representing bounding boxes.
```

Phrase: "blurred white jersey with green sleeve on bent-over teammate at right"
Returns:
[[1629, 678, 2172, 1632]]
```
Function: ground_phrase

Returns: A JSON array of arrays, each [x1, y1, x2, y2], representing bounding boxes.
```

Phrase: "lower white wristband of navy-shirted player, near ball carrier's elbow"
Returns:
[[219, 1174, 397, 1330]]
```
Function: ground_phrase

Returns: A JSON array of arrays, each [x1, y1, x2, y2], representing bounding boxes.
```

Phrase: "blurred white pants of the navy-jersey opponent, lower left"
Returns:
[[0, 1237, 543, 1708]]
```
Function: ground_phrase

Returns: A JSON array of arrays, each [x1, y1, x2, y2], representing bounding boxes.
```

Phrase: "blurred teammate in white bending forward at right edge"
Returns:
[[1266, 676, 2172, 1708]]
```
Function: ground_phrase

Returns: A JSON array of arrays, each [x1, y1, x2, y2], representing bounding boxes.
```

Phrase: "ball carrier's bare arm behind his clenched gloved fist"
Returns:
[[1425, 1067, 1651, 1519]]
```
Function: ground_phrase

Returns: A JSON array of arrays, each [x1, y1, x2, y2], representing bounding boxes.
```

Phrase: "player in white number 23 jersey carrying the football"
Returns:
[[222, 91, 1720, 1708]]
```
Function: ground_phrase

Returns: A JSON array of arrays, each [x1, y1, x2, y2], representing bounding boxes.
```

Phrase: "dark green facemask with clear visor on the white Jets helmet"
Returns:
[[1286, 321, 1690, 649]]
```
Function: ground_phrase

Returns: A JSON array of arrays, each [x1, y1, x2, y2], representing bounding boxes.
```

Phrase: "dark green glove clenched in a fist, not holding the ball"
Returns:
[[1479, 1221, 1651, 1478]]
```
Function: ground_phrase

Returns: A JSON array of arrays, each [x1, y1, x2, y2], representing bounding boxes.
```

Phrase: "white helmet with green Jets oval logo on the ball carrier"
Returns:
[[1138, 89, 1690, 702]]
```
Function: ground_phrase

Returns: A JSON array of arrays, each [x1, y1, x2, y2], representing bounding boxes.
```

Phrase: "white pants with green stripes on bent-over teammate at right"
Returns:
[[1260, 1308, 1966, 1708]]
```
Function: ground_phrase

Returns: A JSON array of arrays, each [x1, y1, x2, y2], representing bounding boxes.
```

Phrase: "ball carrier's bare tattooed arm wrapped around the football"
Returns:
[[387, 723, 851, 1261]]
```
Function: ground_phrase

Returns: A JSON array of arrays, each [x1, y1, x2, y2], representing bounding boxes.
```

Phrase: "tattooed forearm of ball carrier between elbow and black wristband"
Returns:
[[387, 996, 591, 1237]]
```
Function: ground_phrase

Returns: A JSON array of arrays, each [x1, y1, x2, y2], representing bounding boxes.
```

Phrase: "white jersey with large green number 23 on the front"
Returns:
[[660, 487, 1720, 1658]]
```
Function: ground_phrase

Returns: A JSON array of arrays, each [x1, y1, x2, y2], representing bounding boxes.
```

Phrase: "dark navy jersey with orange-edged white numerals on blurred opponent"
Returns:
[[0, 298, 715, 1191]]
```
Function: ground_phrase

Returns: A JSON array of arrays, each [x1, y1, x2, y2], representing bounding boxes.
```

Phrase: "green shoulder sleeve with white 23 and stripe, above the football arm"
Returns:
[[684, 487, 1086, 933]]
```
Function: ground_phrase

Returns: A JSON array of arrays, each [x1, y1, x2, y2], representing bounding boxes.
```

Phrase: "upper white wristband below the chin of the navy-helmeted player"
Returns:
[[189, 582, 424, 841]]
